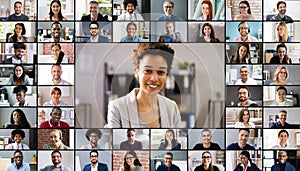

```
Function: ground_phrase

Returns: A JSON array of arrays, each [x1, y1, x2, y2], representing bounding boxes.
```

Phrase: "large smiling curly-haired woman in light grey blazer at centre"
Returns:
[[108, 43, 181, 128]]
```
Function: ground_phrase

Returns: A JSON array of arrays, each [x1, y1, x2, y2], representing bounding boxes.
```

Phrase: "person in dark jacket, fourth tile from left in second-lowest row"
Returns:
[[120, 129, 143, 150]]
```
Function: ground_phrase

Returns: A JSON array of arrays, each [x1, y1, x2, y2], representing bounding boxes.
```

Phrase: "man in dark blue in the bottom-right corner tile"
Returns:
[[271, 151, 296, 171]]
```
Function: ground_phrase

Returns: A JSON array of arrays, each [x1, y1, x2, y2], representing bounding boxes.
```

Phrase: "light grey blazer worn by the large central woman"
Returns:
[[108, 89, 182, 128]]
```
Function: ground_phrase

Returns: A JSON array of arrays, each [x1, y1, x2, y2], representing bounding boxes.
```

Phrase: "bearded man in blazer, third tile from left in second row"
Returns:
[[83, 21, 108, 43]]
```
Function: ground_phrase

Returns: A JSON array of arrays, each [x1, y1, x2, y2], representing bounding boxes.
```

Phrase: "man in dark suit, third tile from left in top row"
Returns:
[[80, 1, 108, 21]]
